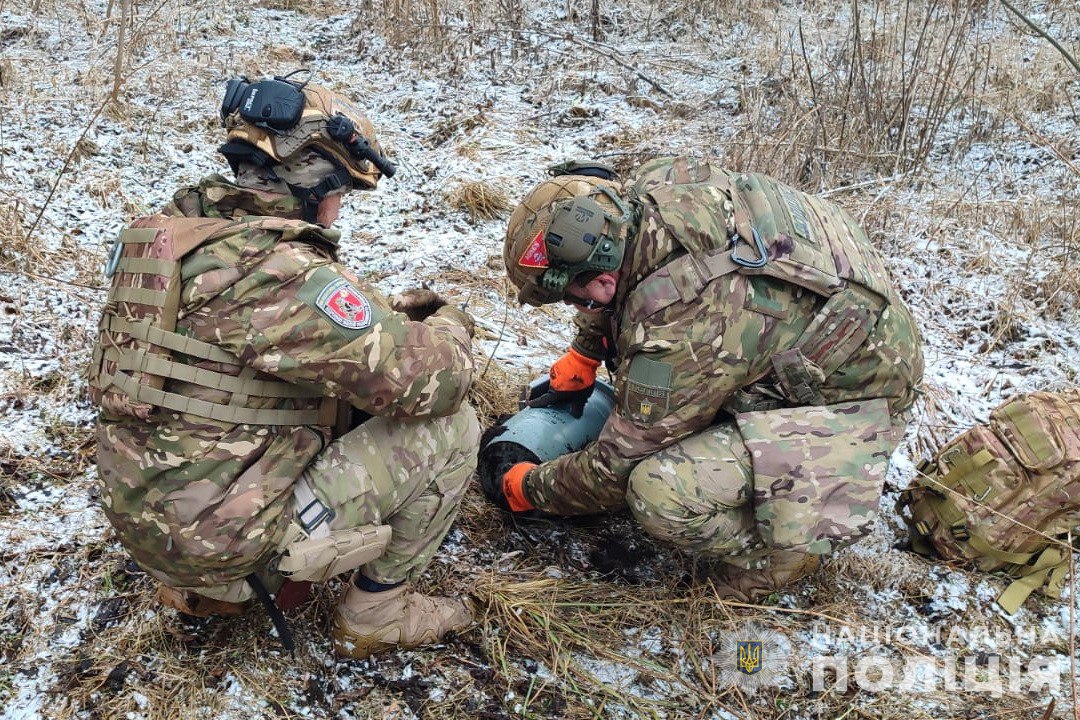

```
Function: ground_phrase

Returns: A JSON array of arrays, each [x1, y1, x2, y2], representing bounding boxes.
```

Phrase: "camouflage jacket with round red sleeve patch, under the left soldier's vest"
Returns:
[[97, 176, 472, 587]]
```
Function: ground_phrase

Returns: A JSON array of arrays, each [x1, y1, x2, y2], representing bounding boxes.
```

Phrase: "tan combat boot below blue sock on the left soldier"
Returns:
[[334, 583, 473, 660]]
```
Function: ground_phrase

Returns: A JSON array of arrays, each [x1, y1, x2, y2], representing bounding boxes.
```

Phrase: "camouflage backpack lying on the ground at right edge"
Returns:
[[896, 390, 1080, 614]]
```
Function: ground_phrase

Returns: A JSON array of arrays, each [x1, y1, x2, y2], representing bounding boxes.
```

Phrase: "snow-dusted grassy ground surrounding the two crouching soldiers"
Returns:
[[0, 0, 1080, 720]]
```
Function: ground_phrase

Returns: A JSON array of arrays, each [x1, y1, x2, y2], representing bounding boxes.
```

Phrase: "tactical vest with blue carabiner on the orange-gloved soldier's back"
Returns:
[[629, 158, 892, 412]]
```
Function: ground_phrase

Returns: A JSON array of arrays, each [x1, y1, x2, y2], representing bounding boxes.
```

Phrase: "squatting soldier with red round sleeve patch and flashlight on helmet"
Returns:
[[92, 78, 478, 657]]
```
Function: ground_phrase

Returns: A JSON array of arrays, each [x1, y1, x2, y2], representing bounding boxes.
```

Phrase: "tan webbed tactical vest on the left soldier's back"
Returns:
[[90, 215, 338, 426]]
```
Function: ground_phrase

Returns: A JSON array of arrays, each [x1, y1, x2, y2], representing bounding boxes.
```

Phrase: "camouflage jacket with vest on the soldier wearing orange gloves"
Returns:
[[525, 158, 922, 515]]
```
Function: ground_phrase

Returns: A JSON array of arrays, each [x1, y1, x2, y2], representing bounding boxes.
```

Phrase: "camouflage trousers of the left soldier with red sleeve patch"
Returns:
[[303, 405, 480, 583]]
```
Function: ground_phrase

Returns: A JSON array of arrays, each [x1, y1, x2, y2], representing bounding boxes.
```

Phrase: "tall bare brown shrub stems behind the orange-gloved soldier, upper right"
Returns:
[[732, 0, 988, 189]]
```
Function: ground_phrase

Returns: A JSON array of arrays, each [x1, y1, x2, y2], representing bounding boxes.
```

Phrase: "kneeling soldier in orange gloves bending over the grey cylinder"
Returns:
[[485, 158, 922, 600]]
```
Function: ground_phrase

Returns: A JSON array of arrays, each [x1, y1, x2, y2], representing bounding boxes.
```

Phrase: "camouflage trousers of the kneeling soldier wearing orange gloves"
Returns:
[[626, 399, 906, 568]]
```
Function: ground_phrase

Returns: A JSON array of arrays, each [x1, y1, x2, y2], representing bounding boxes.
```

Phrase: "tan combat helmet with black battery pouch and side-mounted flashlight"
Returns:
[[218, 72, 396, 221]]
